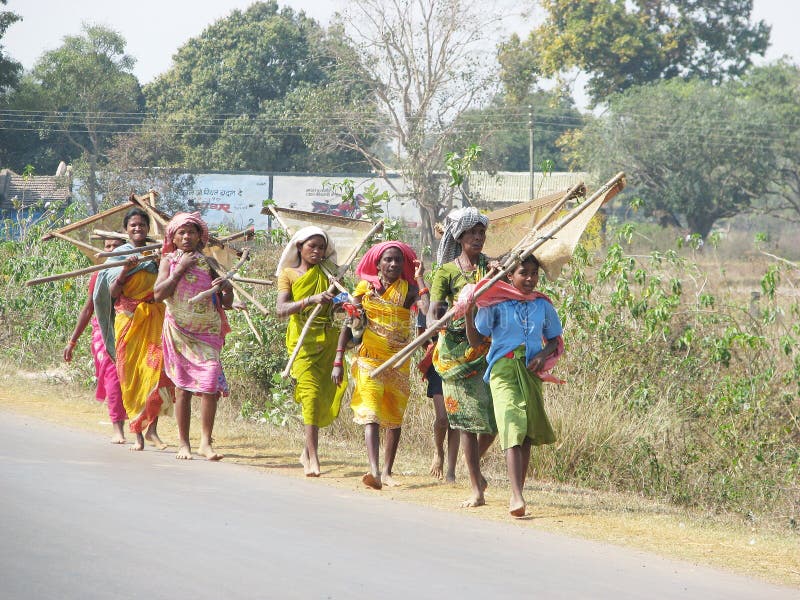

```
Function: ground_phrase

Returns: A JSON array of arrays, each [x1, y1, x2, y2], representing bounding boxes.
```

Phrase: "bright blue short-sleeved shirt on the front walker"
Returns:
[[475, 298, 562, 383]]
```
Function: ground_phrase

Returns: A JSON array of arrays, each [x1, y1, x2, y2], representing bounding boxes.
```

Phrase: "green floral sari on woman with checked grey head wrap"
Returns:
[[431, 255, 497, 435]]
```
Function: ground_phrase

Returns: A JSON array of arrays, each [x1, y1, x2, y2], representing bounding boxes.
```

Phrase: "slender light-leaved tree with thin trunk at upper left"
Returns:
[[30, 24, 143, 211]]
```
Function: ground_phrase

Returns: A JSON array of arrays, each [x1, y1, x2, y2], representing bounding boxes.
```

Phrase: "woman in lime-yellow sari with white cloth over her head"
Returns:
[[276, 227, 347, 477]]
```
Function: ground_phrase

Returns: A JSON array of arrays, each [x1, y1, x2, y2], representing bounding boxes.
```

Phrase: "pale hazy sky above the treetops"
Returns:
[[0, 0, 800, 92]]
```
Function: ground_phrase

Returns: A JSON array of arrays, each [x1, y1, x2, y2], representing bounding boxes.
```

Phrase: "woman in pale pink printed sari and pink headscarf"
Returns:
[[153, 213, 233, 460]]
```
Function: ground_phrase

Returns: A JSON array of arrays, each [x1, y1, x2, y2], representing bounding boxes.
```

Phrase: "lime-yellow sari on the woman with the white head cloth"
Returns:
[[286, 265, 347, 427]]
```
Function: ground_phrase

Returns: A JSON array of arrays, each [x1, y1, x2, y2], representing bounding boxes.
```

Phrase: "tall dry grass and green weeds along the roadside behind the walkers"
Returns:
[[0, 212, 800, 528]]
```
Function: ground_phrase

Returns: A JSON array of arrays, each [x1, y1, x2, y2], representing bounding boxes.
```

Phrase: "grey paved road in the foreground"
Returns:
[[0, 411, 800, 600]]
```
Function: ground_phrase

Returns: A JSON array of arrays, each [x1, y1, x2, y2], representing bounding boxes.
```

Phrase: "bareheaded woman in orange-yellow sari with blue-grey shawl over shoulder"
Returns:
[[94, 208, 175, 450]]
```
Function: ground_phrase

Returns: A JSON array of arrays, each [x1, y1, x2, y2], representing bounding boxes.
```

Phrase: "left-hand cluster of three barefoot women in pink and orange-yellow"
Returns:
[[64, 207, 233, 460]]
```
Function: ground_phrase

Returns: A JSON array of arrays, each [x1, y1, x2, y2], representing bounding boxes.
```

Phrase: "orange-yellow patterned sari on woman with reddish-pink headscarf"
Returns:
[[350, 279, 413, 429]]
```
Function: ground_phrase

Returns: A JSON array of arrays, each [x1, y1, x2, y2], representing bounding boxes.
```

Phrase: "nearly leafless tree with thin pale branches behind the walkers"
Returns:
[[296, 0, 499, 243]]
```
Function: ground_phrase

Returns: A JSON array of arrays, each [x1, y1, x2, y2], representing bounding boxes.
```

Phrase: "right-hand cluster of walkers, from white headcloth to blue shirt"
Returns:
[[277, 208, 563, 516]]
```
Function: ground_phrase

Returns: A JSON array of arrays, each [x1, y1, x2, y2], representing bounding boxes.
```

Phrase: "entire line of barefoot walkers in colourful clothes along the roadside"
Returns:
[[64, 208, 563, 516]]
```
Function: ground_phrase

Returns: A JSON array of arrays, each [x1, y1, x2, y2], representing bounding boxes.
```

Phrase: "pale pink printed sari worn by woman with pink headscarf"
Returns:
[[162, 251, 230, 396]]
